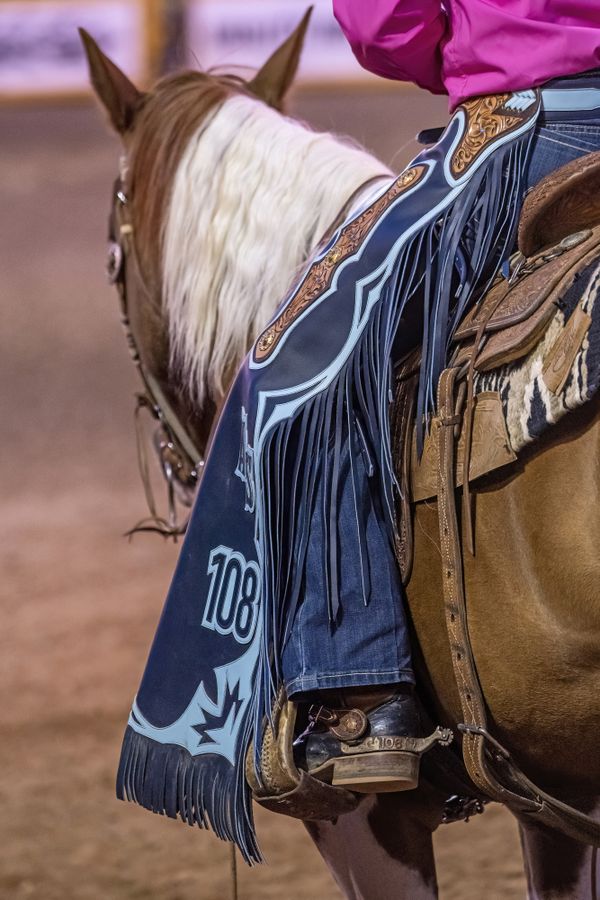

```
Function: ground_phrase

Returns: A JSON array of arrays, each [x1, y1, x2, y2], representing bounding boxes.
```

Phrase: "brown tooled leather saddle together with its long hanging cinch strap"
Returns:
[[392, 152, 600, 847]]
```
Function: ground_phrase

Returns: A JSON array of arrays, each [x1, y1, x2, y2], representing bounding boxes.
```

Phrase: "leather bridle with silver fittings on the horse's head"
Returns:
[[106, 158, 204, 540]]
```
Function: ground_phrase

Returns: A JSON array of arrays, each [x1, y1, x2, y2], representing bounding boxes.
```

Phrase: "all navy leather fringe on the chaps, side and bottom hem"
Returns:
[[117, 114, 531, 864]]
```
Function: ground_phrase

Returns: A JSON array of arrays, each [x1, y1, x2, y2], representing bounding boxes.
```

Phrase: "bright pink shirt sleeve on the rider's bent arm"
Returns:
[[333, 0, 448, 94]]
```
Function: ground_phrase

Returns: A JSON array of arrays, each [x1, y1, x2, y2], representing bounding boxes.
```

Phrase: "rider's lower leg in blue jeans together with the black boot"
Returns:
[[281, 342, 423, 791]]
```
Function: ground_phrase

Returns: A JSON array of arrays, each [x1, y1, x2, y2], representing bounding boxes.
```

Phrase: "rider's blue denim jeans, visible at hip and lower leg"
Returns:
[[281, 115, 600, 699]]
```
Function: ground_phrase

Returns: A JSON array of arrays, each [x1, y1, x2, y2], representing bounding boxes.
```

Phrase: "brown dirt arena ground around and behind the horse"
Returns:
[[0, 86, 524, 900]]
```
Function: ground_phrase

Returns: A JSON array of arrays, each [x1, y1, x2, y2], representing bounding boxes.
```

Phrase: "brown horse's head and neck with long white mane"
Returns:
[[81, 10, 387, 532]]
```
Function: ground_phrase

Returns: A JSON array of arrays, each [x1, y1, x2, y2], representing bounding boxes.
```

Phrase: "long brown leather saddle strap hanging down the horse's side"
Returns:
[[432, 367, 600, 846]]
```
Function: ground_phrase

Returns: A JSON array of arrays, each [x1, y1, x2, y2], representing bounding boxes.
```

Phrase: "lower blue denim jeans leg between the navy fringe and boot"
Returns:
[[282, 432, 414, 697]]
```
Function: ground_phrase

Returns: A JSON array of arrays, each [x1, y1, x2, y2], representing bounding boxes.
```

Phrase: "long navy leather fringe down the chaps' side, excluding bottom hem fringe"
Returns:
[[254, 133, 531, 766]]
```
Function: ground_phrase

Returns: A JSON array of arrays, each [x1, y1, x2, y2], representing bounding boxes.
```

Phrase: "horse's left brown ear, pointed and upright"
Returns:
[[79, 28, 144, 135]]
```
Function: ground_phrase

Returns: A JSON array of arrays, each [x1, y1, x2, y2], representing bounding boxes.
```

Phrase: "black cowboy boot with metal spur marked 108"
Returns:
[[294, 684, 452, 794]]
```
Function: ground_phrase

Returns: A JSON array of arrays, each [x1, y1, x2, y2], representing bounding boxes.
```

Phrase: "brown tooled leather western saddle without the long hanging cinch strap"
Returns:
[[392, 152, 600, 583]]
